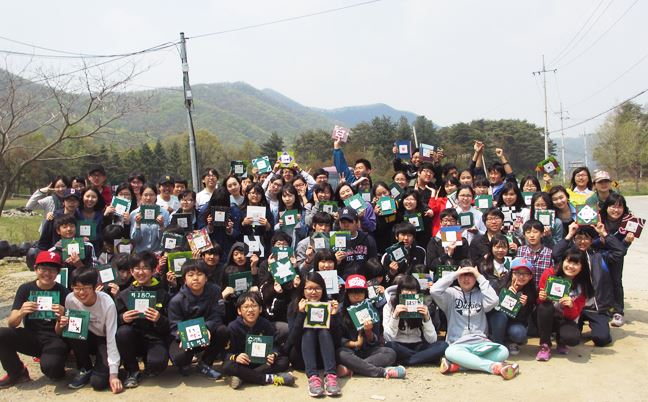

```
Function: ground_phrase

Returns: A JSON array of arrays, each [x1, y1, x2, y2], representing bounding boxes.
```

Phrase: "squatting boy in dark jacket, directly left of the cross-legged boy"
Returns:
[[169, 261, 229, 380]]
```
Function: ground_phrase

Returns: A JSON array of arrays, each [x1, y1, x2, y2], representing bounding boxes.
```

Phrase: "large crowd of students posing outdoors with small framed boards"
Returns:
[[0, 140, 634, 397]]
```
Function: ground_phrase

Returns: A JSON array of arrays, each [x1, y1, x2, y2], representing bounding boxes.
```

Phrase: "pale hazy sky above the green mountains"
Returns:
[[0, 0, 648, 138]]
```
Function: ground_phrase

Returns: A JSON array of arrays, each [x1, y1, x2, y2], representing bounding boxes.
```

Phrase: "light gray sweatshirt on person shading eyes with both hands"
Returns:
[[430, 272, 499, 344]]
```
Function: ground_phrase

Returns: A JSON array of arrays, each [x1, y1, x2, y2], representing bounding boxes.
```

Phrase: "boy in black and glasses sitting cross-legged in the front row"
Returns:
[[223, 292, 295, 389]]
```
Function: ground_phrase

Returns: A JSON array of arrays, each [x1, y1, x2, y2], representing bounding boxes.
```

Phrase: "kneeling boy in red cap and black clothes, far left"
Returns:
[[0, 251, 68, 389]]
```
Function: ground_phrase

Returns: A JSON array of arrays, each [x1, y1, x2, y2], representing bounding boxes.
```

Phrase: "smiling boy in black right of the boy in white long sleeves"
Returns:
[[115, 251, 169, 388]]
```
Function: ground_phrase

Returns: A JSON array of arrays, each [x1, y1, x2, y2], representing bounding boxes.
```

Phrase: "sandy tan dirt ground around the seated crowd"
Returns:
[[0, 196, 648, 401]]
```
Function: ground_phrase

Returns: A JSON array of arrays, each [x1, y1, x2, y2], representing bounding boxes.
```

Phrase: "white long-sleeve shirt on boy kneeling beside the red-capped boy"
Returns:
[[65, 292, 120, 374]]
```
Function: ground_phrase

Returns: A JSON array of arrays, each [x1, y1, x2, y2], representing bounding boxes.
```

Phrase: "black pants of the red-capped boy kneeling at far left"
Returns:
[[0, 328, 68, 379]]
